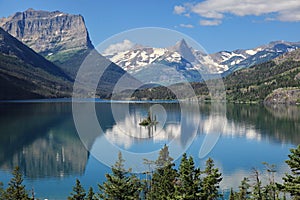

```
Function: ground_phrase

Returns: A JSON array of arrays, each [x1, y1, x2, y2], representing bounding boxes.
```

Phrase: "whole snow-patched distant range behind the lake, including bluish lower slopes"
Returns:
[[103, 39, 300, 83]]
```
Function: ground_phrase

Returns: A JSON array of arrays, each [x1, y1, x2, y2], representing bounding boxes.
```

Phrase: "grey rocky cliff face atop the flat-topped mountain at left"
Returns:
[[0, 9, 93, 57]]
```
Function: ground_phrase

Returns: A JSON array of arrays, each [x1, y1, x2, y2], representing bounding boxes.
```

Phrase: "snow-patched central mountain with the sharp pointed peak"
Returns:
[[102, 39, 227, 84]]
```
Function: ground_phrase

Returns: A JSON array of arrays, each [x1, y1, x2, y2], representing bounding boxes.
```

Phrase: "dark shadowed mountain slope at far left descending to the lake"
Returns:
[[0, 28, 73, 99]]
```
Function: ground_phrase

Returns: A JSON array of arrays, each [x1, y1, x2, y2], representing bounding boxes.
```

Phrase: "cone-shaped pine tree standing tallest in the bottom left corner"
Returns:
[[3, 167, 30, 200]]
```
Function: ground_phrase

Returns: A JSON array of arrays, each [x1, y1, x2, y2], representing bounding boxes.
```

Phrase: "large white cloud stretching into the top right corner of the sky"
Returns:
[[174, 0, 300, 25]]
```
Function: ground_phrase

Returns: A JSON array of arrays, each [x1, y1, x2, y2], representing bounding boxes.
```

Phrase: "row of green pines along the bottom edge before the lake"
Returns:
[[5, 145, 300, 200]]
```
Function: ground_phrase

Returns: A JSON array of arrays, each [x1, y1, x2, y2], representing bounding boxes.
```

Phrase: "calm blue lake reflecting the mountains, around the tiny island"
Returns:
[[0, 101, 300, 199]]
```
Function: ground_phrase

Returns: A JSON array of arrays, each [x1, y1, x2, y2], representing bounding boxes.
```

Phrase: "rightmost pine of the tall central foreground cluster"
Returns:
[[200, 158, 223, 200]]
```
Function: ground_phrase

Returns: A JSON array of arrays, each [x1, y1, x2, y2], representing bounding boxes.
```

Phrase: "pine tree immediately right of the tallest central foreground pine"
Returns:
[[175, 153, 201, 199]]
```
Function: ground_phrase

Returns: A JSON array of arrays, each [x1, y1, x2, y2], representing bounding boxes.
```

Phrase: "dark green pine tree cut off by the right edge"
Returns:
[[283, 145, 300, 199]]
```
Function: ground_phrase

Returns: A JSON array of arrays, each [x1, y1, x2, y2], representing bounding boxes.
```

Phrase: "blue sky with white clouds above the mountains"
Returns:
[[0, 0, 300, 53]]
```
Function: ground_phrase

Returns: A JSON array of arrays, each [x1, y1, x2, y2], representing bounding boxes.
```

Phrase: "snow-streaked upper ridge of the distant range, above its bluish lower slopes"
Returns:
[[105, 39, 300, 78]]
